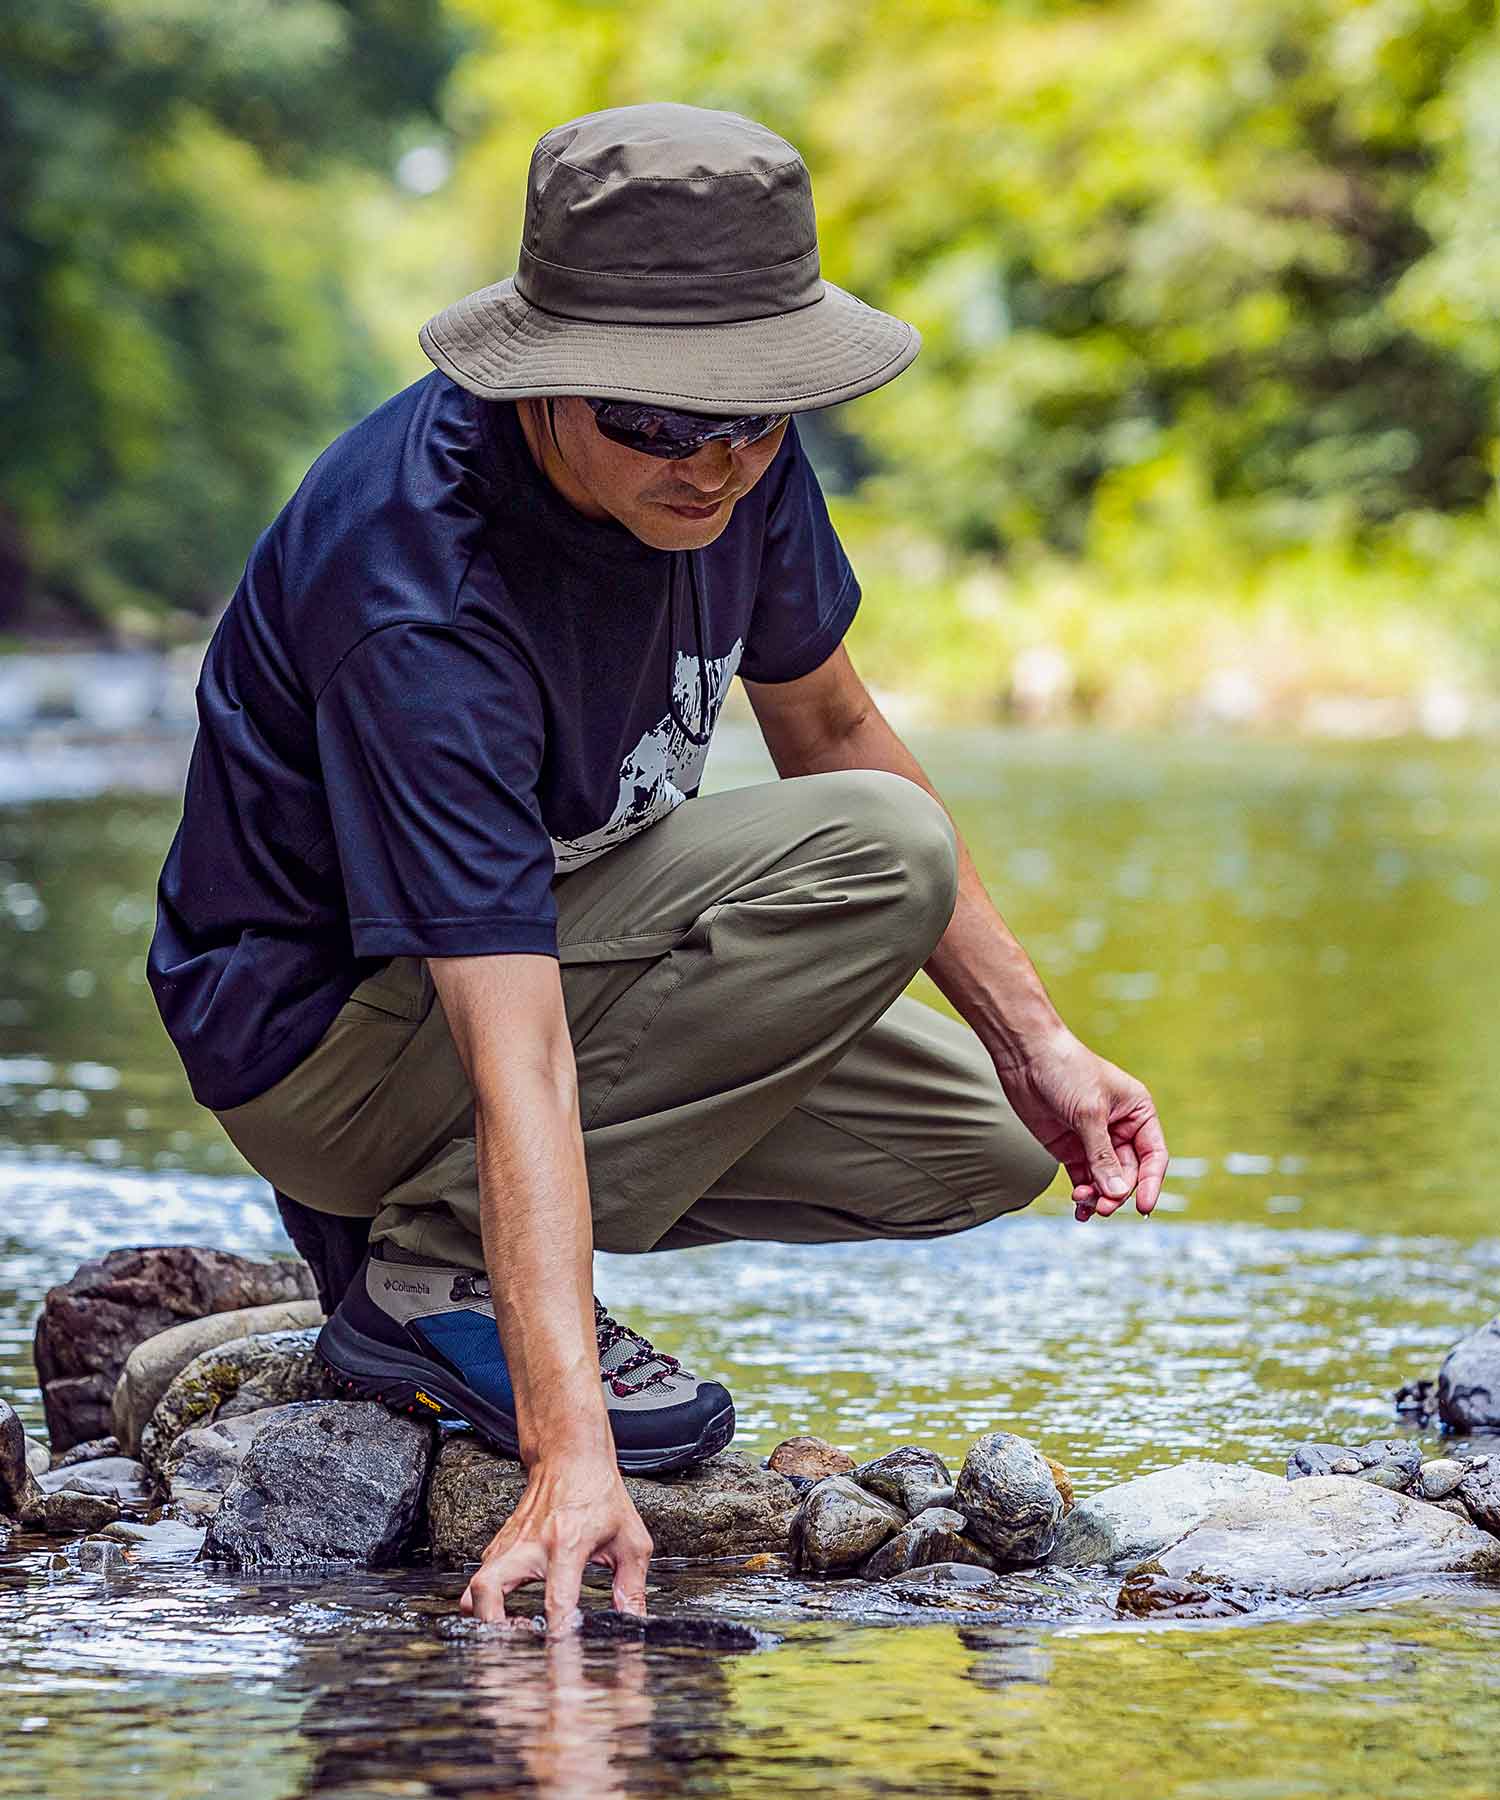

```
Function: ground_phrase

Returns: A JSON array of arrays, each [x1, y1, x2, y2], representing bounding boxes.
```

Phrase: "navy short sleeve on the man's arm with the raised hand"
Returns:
[[740, 418, 859, 680]]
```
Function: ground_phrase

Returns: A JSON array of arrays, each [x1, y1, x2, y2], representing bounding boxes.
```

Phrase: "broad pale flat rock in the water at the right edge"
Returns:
[[1118, 1476, 1500, 1616]]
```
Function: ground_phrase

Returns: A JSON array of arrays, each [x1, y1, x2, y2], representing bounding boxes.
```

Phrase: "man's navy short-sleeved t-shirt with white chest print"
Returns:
[[146, 371, 859, 1111]]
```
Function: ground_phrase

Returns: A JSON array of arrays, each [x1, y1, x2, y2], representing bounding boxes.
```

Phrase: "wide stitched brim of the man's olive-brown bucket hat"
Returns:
[[418, 277, 922, 418]]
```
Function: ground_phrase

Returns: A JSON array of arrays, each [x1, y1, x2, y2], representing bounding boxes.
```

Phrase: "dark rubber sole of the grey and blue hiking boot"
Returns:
[[315, 1312, 735, 1474]]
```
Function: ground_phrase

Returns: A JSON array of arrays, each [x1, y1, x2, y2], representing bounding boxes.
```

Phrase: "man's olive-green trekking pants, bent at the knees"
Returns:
[[216, 770, 1057, 1269]]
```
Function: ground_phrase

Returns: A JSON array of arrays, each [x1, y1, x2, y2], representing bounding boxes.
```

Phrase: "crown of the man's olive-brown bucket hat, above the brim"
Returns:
[[515, 101, 823, 324]]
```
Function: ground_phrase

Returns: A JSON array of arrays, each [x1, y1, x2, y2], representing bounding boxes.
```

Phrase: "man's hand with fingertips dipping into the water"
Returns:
[[459, 1456, 652, 1633]]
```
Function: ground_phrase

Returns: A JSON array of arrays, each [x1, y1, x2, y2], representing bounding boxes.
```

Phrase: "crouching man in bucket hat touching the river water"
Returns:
[[149, 104, 1167, 1627]]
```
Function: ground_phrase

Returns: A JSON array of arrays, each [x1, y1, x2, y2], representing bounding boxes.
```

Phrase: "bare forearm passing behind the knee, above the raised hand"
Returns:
[[782, 704, 1064, 1064]]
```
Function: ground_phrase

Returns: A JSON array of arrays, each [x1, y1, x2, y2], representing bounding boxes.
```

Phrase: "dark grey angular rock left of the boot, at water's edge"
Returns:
[[203, 1400, 434, 1570]]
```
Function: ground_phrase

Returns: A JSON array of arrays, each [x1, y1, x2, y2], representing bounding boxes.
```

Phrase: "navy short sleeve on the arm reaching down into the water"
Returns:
[[317, 625, 556, 956]]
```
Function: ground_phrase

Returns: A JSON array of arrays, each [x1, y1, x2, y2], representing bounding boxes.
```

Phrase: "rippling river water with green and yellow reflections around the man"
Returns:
[[0, 727, 1500, 1800]]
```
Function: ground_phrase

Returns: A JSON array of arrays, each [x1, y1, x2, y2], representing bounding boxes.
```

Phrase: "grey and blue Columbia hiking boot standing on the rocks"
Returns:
[[317, 1246, 735, 1472]]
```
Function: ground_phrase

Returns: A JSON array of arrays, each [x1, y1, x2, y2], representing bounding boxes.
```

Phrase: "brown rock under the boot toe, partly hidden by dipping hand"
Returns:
[[427, 1435, 796, 1564]]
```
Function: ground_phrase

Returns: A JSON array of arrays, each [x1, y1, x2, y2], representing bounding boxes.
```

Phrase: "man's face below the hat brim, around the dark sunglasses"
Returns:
[[519, 394, 787, 551]]
